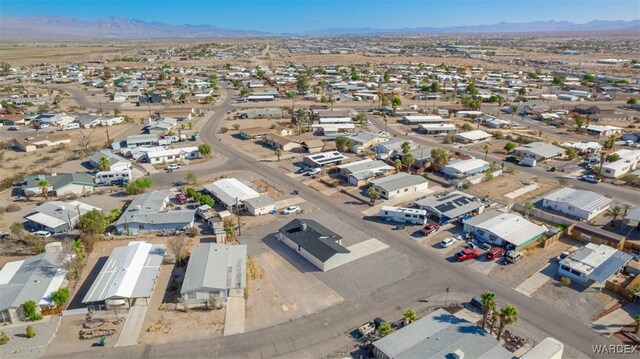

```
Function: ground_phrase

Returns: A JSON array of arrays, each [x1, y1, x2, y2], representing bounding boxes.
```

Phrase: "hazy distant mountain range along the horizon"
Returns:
[[0, 16, 640, 40]]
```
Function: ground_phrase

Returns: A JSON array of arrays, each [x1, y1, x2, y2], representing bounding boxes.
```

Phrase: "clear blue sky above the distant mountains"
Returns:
[[0, 0, 640, 33]]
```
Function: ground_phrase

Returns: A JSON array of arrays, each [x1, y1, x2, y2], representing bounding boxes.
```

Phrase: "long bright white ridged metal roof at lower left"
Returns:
[[82, 241, 166, 303]]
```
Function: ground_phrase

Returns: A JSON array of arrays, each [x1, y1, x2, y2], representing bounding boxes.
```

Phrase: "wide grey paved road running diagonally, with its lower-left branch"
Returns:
[[46, 85, 615, 358]]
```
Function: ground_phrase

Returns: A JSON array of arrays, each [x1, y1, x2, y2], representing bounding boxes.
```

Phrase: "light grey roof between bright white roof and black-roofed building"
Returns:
[[180, 243, 247, 294]]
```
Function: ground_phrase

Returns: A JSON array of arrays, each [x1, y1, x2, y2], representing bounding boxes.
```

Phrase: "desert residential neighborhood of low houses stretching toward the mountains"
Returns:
[[0, 3, 640, 359]]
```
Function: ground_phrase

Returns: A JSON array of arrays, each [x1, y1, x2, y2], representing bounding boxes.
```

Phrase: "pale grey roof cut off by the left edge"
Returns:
[[0, 253, 67, 310]]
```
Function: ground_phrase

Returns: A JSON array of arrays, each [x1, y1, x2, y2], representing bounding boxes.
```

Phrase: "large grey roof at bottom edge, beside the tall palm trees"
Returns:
[[373, 309, 513, 359]]
